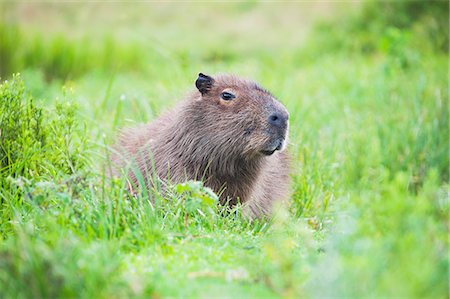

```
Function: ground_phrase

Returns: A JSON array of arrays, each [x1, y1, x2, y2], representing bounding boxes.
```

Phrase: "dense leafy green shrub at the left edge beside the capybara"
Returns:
[[0, 75, 88, 238]]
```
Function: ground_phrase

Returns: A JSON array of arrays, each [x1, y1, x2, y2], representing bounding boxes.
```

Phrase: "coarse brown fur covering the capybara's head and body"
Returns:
[[113, 74, 289, 216]]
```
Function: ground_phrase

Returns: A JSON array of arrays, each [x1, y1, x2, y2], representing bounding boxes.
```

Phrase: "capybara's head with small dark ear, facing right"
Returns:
[[190, 73, 289, 158]]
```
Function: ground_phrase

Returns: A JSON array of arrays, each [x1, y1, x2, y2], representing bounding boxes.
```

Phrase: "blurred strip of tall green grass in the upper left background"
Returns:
[[0, 23, 143, 81]]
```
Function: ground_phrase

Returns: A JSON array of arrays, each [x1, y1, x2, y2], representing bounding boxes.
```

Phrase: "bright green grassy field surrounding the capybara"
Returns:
[[0, 1, 450, 298]]
